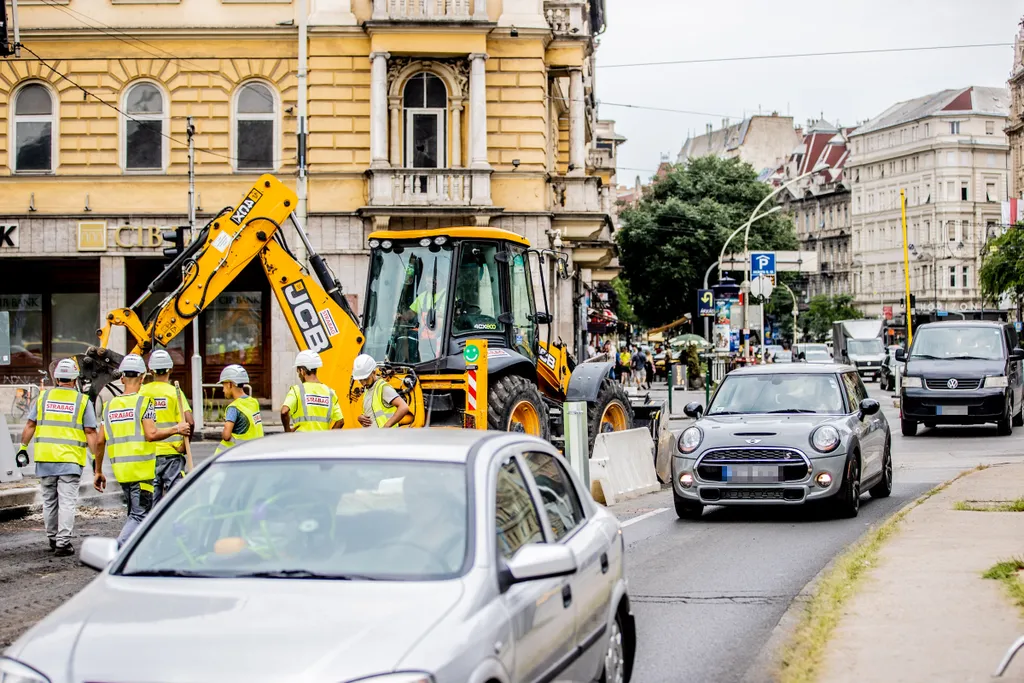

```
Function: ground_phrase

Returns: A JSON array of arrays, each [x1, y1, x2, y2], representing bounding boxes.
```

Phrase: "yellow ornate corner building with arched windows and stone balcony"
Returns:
[[0, 0, 622, 402]]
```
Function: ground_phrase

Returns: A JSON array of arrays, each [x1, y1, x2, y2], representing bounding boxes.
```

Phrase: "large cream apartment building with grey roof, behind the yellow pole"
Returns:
[[846, 86, 1010, 316]]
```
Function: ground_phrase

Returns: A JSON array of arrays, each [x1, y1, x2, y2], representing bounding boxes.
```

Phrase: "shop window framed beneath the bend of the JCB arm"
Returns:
[[204, 292, 263, 367]]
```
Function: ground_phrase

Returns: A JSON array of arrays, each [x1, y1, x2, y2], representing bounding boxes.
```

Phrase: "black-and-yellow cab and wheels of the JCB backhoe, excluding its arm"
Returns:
[[362, 227, 632, 441]]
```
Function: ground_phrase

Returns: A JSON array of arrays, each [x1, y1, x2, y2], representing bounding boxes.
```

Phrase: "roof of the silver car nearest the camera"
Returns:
[[210, 427, 524, 463]]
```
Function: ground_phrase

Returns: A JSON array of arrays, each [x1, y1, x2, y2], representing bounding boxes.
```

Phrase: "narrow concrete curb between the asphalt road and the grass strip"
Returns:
[[739, 465, 995, 683]]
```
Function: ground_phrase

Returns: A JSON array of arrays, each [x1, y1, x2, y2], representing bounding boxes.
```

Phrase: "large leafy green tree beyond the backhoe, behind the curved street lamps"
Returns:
[[617, 157, 798, 328]]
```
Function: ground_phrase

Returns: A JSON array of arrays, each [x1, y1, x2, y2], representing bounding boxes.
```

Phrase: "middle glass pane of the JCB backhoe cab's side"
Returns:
[[452, 242, 505, 335]]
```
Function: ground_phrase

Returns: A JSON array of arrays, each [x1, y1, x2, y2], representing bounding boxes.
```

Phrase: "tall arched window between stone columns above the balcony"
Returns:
[[402, 73, 447, 168]]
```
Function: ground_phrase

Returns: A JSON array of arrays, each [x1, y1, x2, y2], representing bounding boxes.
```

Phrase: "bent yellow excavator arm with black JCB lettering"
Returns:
[[85, 175, 405, 427]]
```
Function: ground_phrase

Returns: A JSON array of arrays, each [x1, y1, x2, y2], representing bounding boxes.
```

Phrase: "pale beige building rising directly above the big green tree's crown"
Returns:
[[676, 112, 803, 177]]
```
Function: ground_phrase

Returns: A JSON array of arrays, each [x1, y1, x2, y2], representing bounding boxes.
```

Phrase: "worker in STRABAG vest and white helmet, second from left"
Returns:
[[92, 353, 188, 548]]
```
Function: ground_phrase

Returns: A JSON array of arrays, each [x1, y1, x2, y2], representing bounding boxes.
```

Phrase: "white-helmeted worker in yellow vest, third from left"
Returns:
[[139, 348, 196, 505]]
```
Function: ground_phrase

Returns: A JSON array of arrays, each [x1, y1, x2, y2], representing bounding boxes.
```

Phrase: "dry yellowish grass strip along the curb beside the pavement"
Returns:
[[776, 465, 988, 683]]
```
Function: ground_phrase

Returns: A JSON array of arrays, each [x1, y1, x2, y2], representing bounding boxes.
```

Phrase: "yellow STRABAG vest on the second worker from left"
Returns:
[[103, 393, 157, 483]]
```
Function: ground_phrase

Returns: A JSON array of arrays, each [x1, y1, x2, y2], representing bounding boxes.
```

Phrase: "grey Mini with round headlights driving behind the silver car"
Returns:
[[672, 364, 893, 519]]
